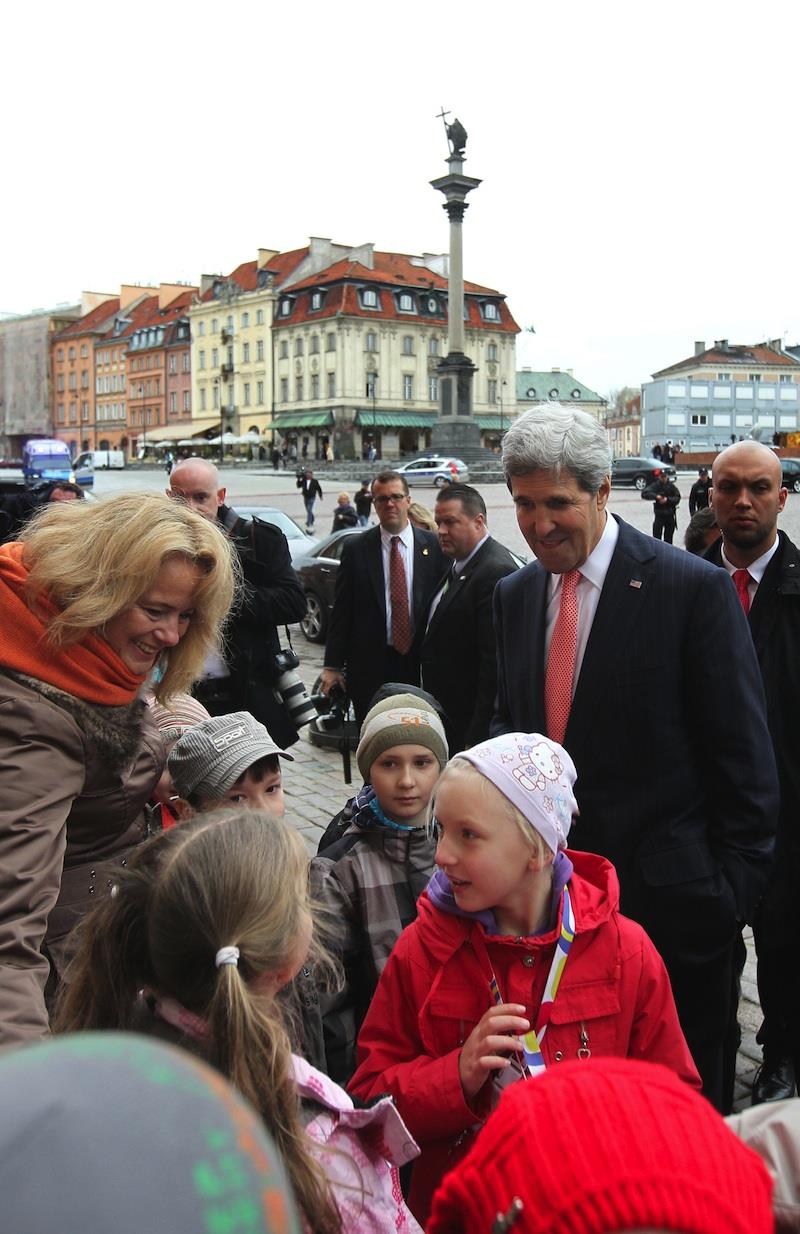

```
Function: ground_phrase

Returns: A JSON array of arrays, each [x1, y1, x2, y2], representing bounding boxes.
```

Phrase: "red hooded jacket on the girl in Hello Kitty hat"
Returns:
[[348, 851, 700, 1225]]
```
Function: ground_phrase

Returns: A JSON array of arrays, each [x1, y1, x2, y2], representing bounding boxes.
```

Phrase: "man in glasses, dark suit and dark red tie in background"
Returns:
[[321, 471, 444, 724]]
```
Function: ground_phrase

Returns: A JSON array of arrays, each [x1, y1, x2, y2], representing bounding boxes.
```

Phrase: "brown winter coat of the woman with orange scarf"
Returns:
[[0, 670, 164, 1045]]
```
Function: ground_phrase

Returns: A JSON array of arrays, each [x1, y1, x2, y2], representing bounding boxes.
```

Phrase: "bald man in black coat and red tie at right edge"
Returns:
[[706, 442, 800, 1104]]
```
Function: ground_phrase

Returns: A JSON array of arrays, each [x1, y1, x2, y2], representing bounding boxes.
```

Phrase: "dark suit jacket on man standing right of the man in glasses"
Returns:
[[421, 537, 517, 754]]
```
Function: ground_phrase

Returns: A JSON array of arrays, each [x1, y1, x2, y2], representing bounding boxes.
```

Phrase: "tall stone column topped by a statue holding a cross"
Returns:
[[431, 120, 481, 454]]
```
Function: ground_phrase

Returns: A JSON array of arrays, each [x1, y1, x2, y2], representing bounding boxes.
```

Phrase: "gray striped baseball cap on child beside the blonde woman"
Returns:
[[167, 711, 294, 797]]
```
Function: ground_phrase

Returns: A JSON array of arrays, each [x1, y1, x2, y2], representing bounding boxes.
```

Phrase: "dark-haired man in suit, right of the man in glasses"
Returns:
[[421, 484, 517, 755]]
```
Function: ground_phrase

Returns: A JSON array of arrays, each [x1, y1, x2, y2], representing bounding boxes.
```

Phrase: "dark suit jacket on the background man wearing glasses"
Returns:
[[325, 527, 446, 722]]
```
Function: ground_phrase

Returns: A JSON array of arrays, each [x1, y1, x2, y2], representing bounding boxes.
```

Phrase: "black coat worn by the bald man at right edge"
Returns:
[[705, 532, 800, 877]]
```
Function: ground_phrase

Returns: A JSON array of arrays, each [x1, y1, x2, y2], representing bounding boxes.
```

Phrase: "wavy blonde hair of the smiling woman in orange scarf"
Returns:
[[20, 492, 241, 702]]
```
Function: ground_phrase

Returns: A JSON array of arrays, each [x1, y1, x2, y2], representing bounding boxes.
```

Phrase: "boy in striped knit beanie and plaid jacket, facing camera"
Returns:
[[311, 694, 447, 1085]]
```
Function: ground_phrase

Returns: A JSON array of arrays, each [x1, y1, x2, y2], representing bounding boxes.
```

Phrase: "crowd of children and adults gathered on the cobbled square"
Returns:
[[0, 417, 800, 1234]]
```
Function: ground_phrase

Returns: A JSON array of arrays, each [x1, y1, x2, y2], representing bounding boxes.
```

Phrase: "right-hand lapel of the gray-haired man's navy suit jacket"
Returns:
[[564, 527, 654, 758]]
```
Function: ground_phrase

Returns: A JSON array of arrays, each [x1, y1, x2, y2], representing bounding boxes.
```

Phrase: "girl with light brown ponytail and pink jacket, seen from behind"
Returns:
[[56, 811, 420, 1234]]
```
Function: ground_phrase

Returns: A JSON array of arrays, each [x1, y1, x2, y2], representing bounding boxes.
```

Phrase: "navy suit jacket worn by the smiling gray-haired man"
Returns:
[[493, 520, 777, 927]]
